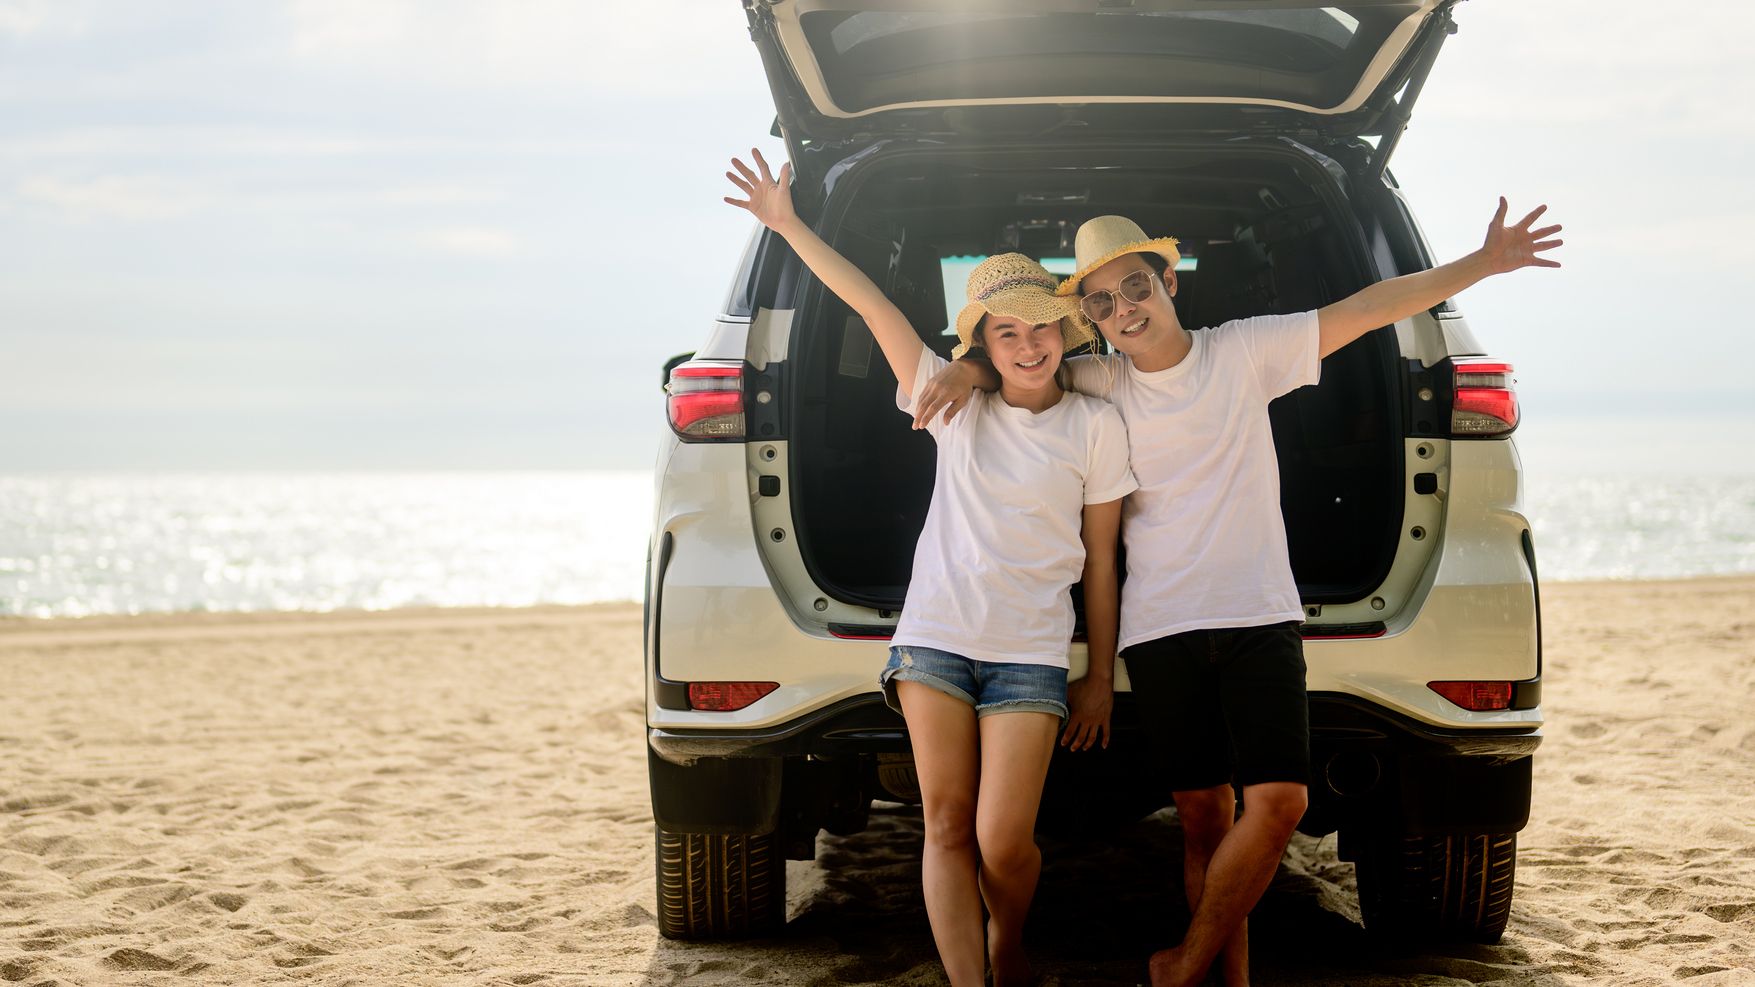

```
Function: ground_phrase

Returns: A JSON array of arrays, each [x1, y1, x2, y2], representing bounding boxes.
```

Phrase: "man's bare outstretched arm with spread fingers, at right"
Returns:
[[1316, 197, 1565, 357]]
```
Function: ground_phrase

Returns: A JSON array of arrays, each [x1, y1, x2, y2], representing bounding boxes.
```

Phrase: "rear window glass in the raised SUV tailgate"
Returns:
[[800, 4, 1420, 112]]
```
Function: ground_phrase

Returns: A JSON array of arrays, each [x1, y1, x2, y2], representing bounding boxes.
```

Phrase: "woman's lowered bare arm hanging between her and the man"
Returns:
[[1060, 501, 1121, 750]]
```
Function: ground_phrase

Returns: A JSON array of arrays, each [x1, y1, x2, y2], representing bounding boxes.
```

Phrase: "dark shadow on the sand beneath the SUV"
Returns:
[[649, 804, 1558, 987]]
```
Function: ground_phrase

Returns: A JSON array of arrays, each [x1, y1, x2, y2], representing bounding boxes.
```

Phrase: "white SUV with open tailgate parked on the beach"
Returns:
[[646, 0, 1543, 941]]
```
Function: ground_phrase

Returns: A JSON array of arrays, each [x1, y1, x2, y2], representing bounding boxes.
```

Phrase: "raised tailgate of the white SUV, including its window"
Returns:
[[744, 0, 1460, 166]]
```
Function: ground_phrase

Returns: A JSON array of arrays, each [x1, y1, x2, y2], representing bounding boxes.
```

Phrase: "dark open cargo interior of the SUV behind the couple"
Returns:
[[788, 149, 1406, 609]]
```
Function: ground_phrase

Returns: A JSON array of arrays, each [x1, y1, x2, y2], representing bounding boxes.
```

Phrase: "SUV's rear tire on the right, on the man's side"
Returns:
[[1355, 832, 1518, 945]]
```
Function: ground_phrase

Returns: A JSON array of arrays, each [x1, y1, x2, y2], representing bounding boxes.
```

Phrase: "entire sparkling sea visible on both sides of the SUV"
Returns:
[[0, 471, 1755, 616]]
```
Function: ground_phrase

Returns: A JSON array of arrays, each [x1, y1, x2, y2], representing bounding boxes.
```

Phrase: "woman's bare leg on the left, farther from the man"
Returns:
[[897, 681, 986, 987]]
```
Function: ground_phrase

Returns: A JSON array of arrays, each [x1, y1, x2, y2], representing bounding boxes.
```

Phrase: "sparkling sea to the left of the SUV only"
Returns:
[[0, 471, 653, 616]]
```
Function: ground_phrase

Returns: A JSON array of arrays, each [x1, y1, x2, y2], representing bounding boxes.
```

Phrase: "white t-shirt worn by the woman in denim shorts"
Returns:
[[890, 346, 1139, 667]]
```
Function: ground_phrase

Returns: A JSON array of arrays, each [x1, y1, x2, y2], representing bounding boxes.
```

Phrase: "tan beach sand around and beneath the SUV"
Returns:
[[0, 578, 1755, 985]]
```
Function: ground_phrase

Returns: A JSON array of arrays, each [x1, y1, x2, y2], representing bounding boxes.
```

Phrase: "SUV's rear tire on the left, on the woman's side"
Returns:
[[653, 825, 786, 940]]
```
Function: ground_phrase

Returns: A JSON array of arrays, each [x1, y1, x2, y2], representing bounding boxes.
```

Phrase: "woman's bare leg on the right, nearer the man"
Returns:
[[976, 713, 1060, 987]]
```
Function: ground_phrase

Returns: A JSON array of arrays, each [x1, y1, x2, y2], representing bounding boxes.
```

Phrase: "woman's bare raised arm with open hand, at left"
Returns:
[[725, 148, 921, 397]]
